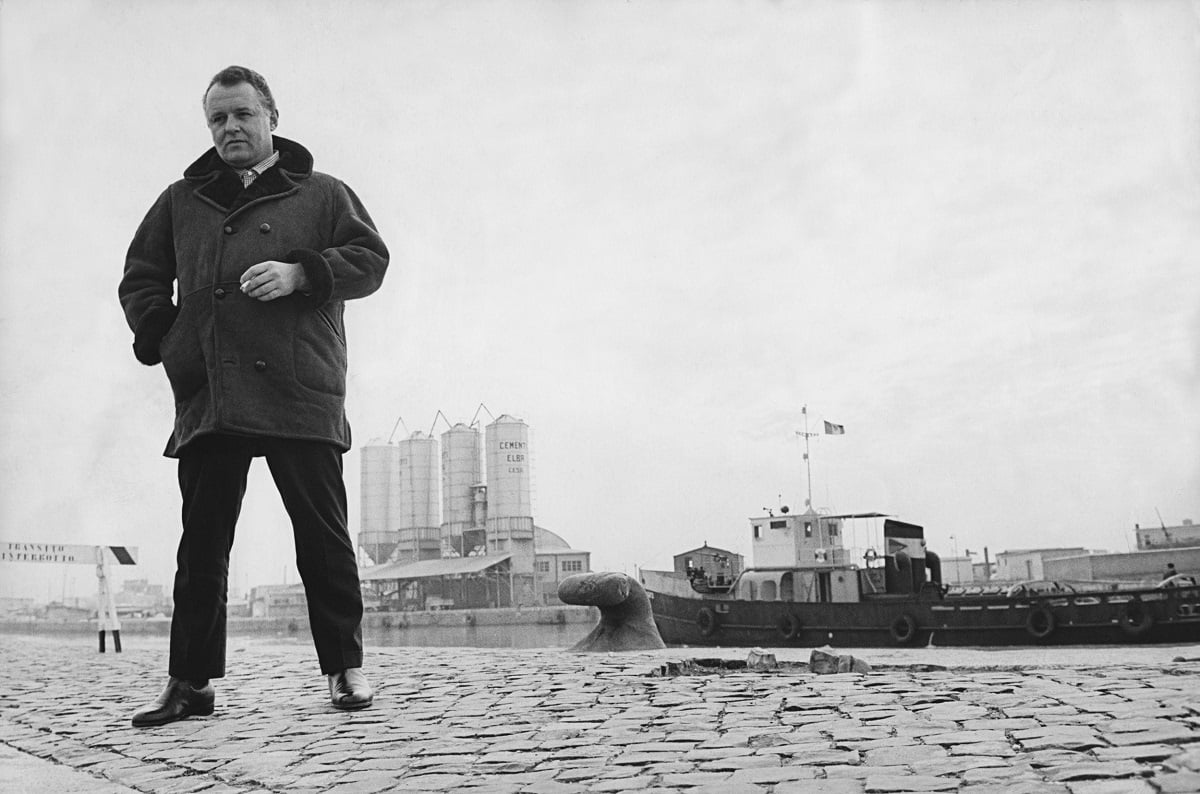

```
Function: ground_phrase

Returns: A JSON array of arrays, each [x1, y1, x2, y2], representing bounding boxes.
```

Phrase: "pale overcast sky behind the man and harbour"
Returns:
[[0, 0, 1200, 600]]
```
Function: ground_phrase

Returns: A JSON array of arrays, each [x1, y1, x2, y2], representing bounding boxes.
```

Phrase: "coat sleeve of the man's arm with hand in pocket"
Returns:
[[116, 188, 179, 365]]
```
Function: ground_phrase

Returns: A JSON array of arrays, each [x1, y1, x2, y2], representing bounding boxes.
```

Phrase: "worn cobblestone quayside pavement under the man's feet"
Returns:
[[0, 636, 1200, 794]]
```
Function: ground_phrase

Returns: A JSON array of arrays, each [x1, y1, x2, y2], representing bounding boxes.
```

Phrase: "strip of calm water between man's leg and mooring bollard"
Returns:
[[362, 624, 592, 648]]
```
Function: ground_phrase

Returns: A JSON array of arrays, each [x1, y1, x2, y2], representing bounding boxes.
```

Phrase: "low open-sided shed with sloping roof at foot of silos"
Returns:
[[359, 554, 512, 609]]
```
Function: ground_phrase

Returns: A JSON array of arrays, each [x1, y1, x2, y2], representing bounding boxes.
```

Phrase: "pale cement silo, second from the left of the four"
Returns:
[[390, 431, 442, 561]]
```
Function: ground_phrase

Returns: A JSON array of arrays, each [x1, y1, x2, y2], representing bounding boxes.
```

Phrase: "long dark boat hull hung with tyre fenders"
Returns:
[[647, 587, 1200, 648]]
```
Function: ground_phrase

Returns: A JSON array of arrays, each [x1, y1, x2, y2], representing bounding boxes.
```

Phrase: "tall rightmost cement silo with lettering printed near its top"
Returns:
[[486, 414, 533, 558]]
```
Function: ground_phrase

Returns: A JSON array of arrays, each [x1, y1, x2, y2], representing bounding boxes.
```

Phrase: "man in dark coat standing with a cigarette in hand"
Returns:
[[119, 66, 388, 727]]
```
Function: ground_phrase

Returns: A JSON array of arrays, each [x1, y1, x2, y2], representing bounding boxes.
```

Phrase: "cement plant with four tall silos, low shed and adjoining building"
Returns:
[[359, 414, 590, 609]]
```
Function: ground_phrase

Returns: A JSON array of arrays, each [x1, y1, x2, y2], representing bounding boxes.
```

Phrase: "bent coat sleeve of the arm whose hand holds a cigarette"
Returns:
[[287, 181, 389, 308]]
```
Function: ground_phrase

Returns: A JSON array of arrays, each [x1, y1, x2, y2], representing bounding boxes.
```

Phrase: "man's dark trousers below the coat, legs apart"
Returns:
[[169, 435, 362, 680]]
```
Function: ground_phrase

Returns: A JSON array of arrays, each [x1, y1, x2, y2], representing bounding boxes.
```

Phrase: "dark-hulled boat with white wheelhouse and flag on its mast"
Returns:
[[640, 408, 1200, 648]]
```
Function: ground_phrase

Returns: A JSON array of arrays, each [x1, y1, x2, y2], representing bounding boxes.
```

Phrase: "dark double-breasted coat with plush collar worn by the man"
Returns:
[[118, 137, 388, 457]]
